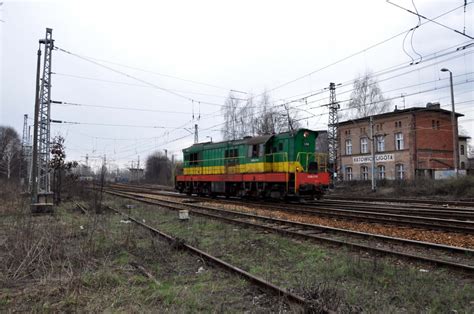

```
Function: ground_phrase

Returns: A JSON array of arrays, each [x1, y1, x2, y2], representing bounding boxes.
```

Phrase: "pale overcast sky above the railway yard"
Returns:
[[0, 0, 474, 170]]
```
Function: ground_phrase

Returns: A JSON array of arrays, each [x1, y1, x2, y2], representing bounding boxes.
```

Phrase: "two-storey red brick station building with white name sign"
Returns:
[[338, 103, 463, 181]]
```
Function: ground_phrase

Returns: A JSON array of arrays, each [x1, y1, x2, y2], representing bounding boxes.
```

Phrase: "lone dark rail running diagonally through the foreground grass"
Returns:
[[108, 206, 308, 307]]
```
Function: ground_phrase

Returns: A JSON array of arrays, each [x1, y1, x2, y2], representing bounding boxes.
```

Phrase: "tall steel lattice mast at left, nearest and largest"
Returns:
[[31, 28, 54, 212]]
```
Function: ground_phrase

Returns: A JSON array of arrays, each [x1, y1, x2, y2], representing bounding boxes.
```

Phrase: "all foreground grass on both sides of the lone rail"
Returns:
[[0, 189, 474, 313]]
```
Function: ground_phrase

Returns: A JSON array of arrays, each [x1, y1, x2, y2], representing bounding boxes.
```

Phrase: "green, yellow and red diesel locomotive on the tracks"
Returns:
[[175, 129, 330, 199]]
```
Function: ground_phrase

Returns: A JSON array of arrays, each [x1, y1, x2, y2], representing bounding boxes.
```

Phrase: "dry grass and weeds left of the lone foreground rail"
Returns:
[[0, 194, 288, 313]]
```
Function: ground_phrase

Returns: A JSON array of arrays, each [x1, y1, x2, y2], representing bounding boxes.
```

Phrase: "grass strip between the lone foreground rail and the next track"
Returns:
[[115, 195, 474, 312]]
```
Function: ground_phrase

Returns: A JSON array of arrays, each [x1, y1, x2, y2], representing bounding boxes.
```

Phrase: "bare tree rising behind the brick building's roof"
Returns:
[[349, 71, 390, 119]]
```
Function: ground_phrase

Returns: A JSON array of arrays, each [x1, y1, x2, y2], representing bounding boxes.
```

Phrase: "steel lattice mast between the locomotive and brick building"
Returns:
[[328, 83, 340, 184]]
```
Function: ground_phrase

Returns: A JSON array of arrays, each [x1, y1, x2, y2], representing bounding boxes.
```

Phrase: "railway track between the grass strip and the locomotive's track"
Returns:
[[106, 190, 474, 272]]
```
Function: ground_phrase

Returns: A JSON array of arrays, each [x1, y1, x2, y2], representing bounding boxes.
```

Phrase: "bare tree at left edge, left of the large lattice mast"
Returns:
[[0, 126, 21, 180]]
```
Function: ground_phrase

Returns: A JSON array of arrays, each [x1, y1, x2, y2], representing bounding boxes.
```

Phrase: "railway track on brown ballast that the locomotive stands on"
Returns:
[[106, 187, 474, 234]]
